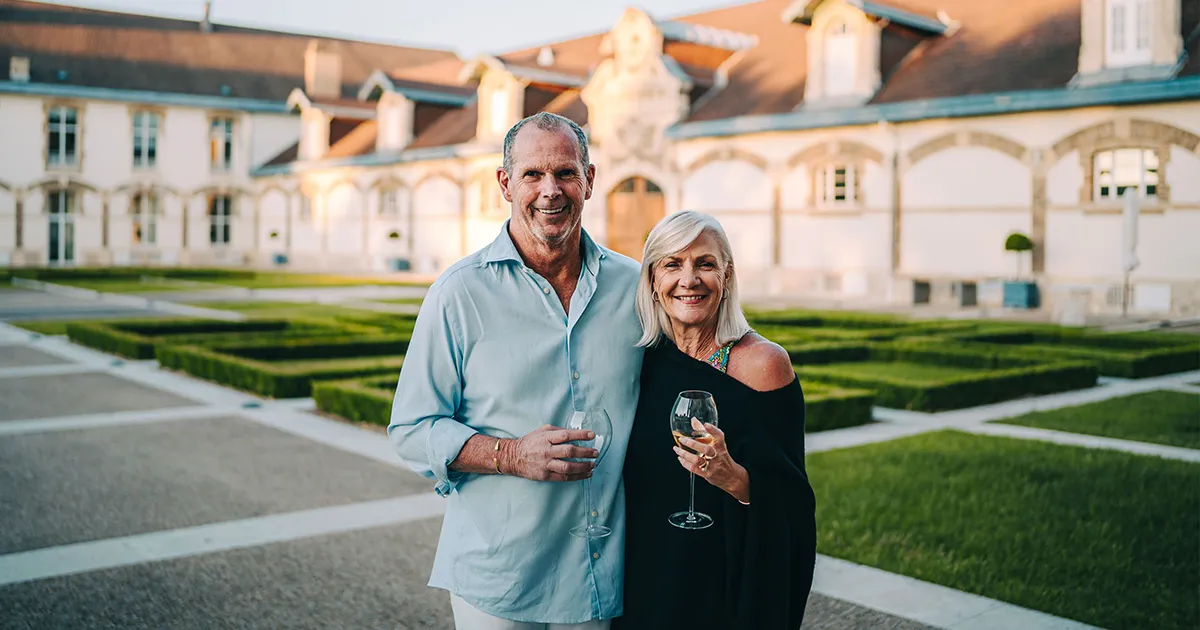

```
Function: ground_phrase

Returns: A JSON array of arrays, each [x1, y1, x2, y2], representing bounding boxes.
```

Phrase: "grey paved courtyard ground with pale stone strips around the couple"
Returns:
[[0, 324, 1123, 630]]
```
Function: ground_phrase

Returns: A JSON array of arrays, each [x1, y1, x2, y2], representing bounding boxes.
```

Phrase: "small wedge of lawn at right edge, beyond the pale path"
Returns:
[[1002, 391, 1200, 449]]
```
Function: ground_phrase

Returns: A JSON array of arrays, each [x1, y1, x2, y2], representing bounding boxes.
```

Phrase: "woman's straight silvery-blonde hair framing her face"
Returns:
[[636, 210, 750, 347]]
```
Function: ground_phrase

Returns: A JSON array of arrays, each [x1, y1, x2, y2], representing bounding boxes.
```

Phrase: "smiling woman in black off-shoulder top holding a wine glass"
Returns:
[[613, 211, 816, 630]]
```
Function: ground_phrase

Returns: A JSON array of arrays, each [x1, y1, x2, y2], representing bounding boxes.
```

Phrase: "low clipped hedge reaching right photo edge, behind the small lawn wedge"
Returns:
[[925, 328, 1200, 378]]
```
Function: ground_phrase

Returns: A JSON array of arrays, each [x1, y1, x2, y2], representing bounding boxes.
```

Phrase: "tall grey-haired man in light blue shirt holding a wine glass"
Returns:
[[388, 113, 643, 630]]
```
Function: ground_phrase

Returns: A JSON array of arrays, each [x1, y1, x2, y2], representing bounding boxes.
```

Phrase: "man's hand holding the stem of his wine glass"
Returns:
[[500, 425, 600, 481]]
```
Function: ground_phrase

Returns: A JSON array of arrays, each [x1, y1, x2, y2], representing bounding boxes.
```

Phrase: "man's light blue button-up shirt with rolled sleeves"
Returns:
[[388, 222, 643, 624]]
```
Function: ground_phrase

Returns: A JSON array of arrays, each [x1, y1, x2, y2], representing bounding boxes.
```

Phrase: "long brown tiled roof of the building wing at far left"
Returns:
[[0, 0, 457, 101]]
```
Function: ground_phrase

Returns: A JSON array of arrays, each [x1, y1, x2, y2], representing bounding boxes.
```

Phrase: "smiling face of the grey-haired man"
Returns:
[[496, 125, 595, 247]]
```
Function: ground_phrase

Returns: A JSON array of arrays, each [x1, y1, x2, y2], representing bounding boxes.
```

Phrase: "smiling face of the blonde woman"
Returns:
[[654, 230, 725, 328]]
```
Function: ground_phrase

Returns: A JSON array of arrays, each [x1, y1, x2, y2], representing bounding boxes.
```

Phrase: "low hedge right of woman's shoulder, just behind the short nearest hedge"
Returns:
[[796, 342, 1098, 412]]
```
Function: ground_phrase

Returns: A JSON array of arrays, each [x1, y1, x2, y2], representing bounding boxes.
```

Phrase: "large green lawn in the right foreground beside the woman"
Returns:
[[808, 431, 1200, 630]]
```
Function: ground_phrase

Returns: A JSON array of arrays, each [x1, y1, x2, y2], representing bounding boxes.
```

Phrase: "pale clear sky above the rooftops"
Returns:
[[30, 0, 744, 58]]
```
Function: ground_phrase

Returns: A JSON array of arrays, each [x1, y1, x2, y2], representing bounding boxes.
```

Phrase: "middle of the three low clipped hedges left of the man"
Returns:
[[155, 336, 408, 398]]
